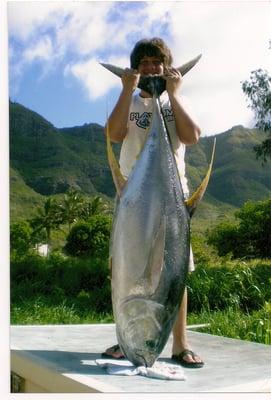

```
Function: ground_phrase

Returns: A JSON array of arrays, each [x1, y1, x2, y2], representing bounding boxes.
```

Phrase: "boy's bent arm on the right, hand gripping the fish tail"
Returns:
[[164, 68, 201, 145]]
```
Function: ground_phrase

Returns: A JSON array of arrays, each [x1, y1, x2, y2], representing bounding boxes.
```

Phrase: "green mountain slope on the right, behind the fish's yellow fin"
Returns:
[[187, 126, 271, 207]]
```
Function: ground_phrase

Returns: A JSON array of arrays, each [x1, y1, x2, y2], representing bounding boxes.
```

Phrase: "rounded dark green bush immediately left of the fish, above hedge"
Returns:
[[64, 214, 112, 257]]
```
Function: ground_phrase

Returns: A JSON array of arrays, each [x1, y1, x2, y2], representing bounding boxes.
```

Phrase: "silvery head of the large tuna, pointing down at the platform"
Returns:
[[117, 297, 166, 367]]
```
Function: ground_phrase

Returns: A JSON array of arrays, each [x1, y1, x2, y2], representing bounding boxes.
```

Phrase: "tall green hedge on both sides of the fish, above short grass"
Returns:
[[11, 253, 271, 322]]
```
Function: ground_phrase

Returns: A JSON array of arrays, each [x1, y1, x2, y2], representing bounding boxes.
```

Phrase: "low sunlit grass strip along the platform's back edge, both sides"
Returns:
[[11, 296, 271, 344]]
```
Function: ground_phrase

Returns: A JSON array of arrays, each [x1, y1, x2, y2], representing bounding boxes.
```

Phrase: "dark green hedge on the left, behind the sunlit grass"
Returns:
[[11, 253, 112, 313]]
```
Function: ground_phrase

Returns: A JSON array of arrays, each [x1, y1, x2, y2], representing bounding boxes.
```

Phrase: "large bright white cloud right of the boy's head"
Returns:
[[168, 2, 271, 133]]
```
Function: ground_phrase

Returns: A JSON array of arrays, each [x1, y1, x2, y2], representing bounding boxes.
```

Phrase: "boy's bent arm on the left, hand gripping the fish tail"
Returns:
[[105, 68, 139, 143]]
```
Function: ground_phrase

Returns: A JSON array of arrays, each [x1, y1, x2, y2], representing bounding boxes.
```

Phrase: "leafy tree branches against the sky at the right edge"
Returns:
[[242, 63, 271, 163]]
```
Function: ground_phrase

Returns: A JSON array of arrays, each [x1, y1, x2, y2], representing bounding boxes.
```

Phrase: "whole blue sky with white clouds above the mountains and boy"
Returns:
[[7, 0, 271, 136]]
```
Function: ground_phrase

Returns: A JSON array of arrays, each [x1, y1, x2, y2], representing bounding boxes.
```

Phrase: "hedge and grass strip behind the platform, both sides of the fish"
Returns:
[[11, 252, 271, 344]]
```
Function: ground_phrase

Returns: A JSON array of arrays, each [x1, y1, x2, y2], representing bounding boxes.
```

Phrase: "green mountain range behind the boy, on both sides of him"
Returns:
[[10, 102, 271, 227]]
